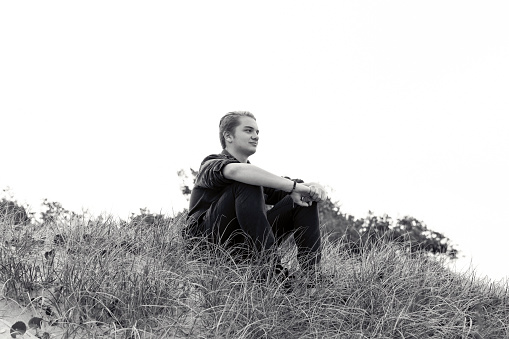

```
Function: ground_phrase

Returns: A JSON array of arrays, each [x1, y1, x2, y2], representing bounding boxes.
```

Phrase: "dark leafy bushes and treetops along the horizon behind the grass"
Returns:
[[0, 168, 458, 259]]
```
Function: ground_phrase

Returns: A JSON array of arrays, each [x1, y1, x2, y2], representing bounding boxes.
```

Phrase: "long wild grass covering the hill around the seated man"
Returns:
[[0, 211, 509, 339]]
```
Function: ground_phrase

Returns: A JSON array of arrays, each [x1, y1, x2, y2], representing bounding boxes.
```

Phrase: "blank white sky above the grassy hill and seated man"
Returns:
[[0, 0, 509, 279]]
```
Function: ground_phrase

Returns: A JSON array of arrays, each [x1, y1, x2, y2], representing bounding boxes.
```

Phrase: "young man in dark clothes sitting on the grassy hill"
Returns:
[[188, 112, 327, 276]]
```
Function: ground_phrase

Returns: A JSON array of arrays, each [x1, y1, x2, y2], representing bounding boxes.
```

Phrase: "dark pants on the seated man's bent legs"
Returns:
[[205, 182, 321, 269]]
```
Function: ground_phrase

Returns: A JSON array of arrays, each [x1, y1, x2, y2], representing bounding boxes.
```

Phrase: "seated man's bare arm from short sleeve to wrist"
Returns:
[[223, 163, 309, 193]]
